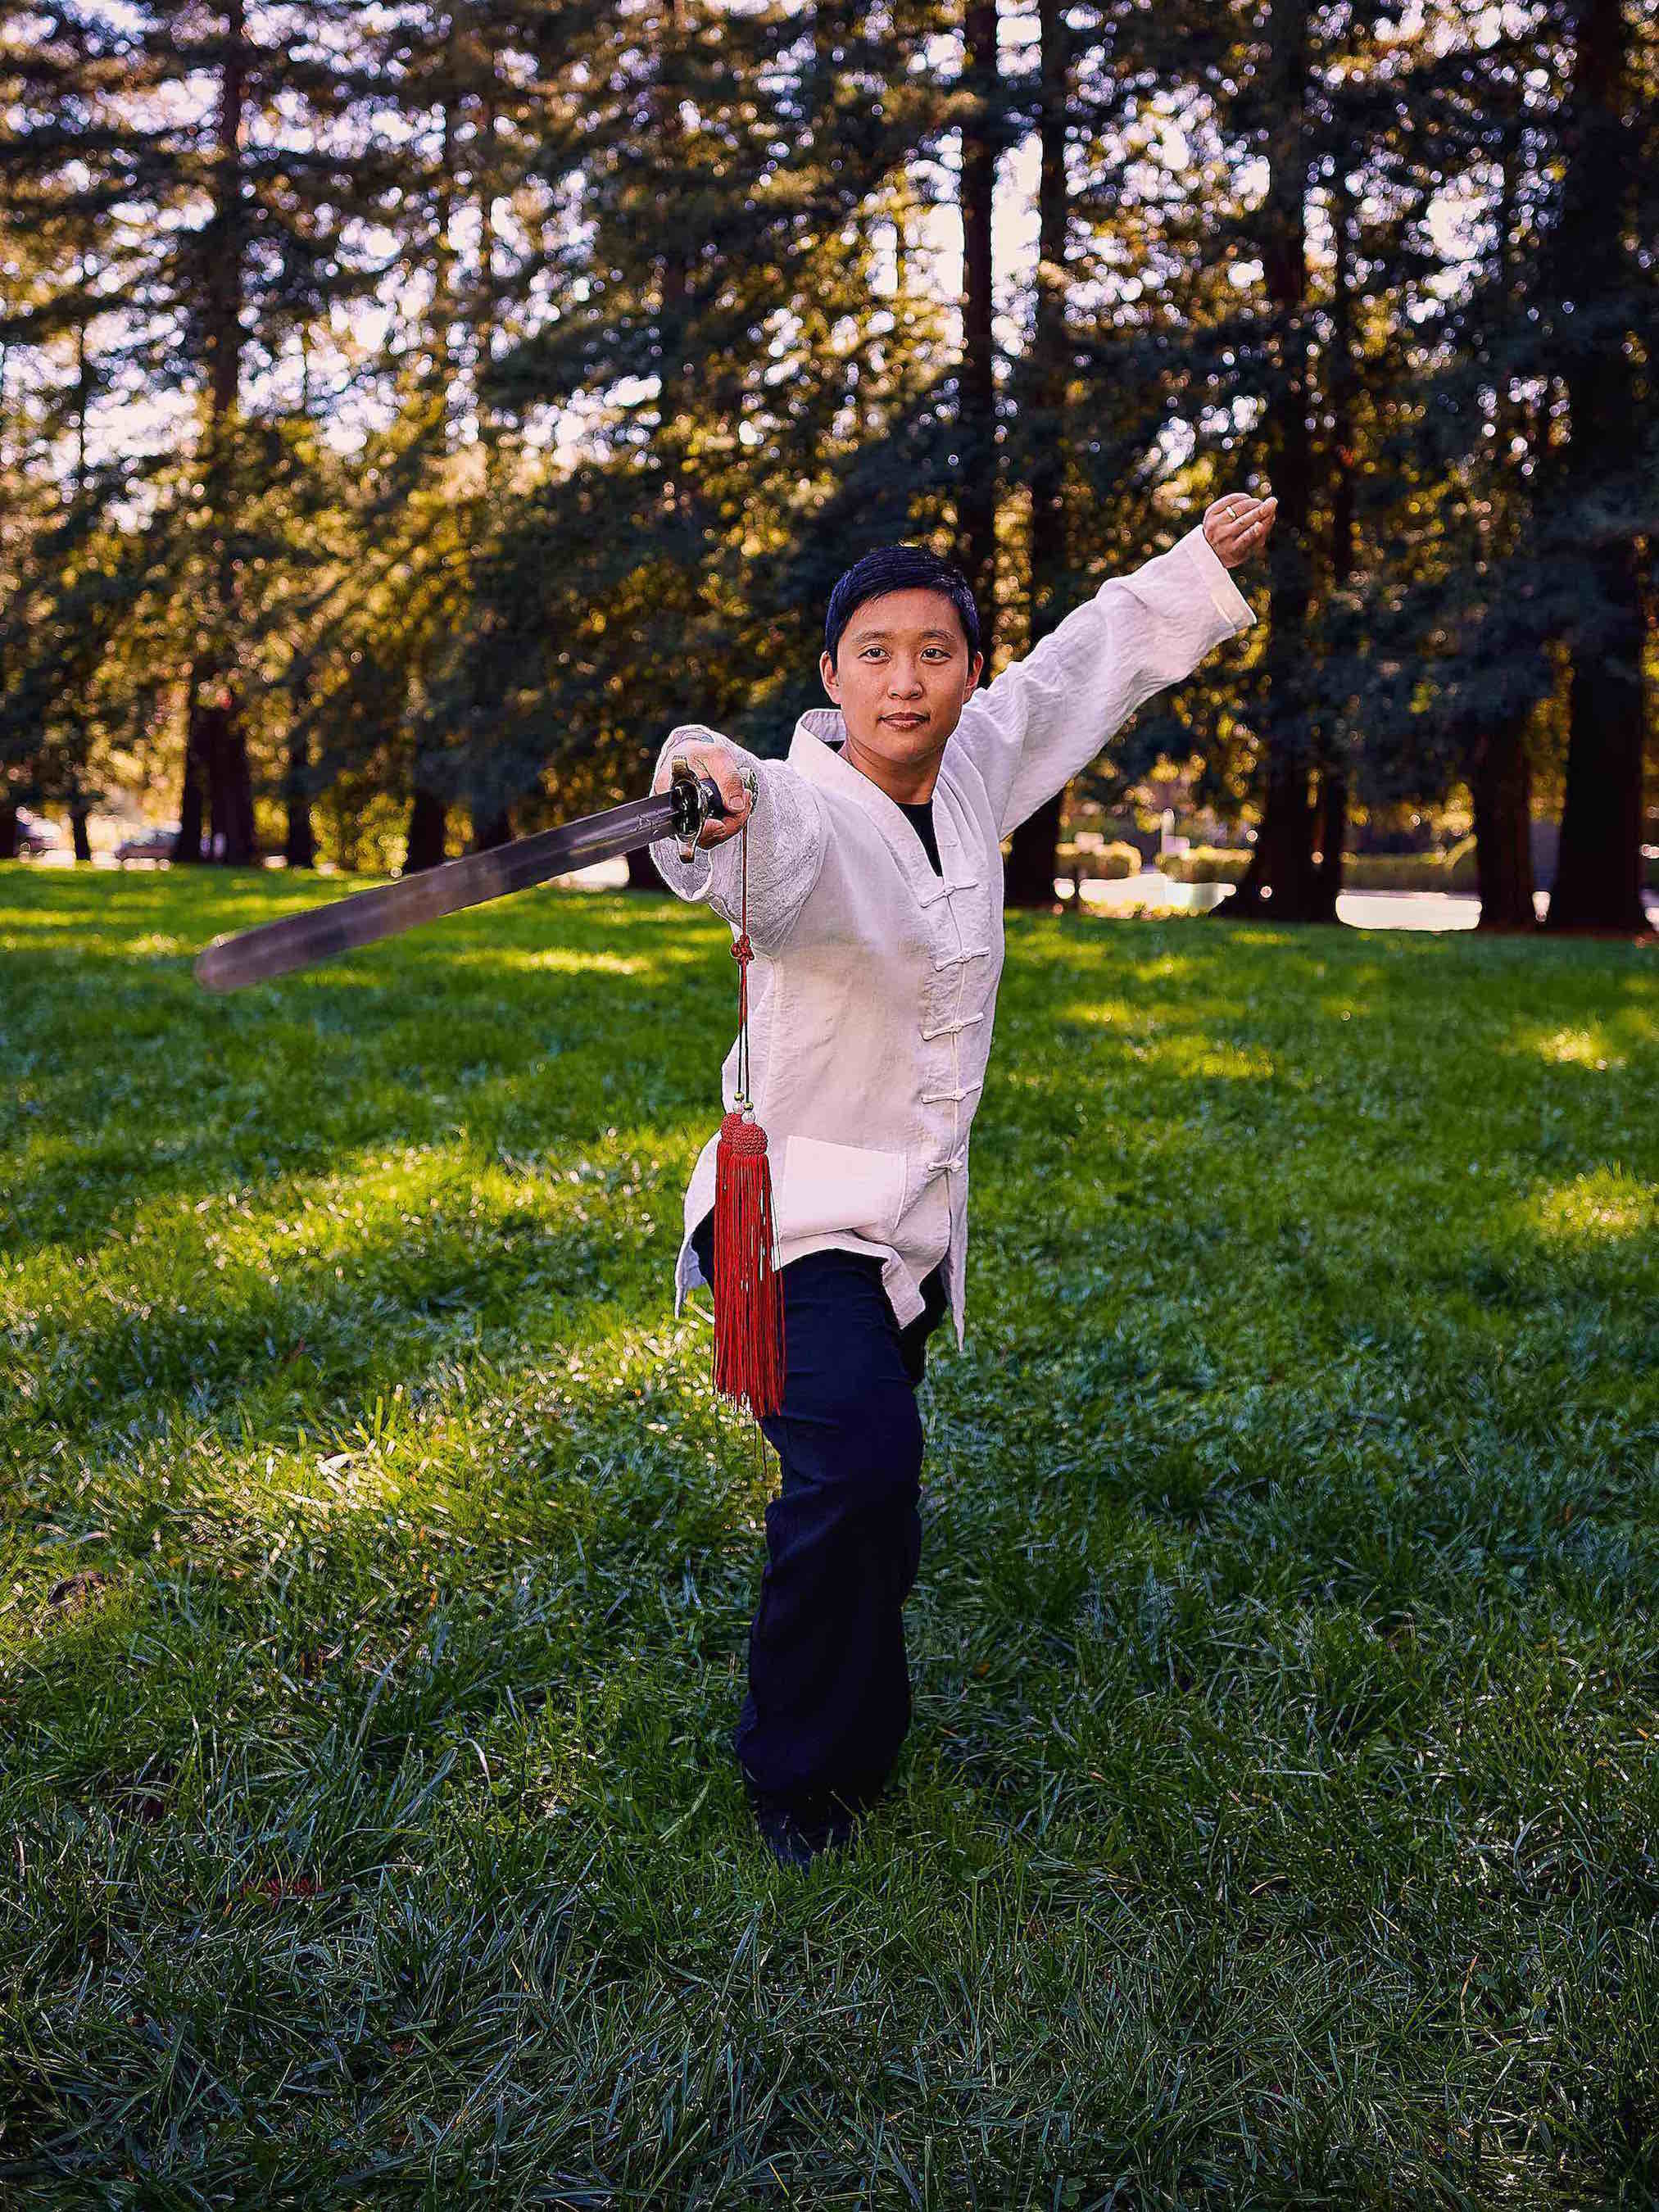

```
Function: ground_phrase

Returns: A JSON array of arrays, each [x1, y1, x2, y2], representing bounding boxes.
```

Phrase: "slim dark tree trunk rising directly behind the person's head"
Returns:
[[955, 0, 999, 646]]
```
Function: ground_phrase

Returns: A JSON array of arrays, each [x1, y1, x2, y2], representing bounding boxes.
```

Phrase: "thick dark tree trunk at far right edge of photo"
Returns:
[[1544, 0, 1648, 931]]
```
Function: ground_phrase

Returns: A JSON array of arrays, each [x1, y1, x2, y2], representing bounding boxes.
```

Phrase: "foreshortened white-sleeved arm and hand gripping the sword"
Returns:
[[650, 721, 830, 954]]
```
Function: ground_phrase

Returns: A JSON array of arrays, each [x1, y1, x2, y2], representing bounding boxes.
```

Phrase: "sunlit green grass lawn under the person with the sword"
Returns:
[[0, 865, 1659, 2212]]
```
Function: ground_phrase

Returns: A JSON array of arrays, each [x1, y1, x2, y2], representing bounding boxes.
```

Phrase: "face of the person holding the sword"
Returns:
[[818, 587, 985, 778]]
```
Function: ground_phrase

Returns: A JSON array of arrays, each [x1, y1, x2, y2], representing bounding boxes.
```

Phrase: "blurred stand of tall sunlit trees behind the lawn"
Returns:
[[0, 0, 1659, 929]]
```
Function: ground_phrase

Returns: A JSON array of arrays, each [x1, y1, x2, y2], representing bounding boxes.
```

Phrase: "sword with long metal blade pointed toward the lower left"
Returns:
[[195, 756, 726, 991]]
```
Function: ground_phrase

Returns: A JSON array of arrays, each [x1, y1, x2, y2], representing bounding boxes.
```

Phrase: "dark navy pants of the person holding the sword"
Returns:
[[692, 1213, 947, 1811]]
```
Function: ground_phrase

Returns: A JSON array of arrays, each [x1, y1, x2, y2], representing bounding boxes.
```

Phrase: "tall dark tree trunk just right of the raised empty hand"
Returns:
[[1213, 0, 1318, 922]]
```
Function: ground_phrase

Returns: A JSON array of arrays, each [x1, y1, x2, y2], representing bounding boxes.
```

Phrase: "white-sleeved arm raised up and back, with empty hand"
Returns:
[[954, 493, 1276, 836]]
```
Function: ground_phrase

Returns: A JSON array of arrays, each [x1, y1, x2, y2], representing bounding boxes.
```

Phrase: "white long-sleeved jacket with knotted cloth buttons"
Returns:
[[650, 524, 1257, 1349]]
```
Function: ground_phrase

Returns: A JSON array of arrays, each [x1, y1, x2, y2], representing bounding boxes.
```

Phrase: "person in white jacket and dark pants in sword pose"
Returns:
[[650, 493, 1276, 1862]]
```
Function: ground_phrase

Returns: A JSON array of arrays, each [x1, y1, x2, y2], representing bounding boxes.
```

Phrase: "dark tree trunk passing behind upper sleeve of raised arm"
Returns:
[[1002, 0, 1068, 907]]
